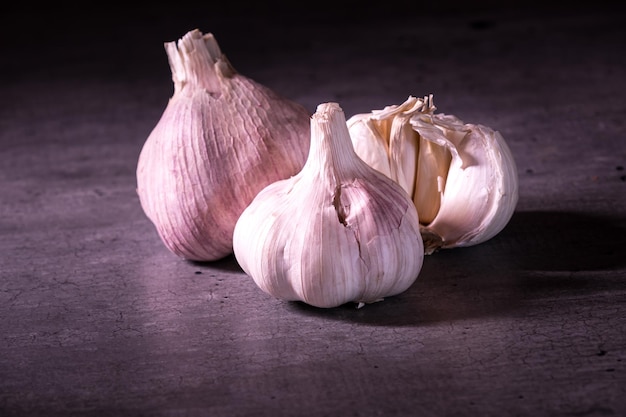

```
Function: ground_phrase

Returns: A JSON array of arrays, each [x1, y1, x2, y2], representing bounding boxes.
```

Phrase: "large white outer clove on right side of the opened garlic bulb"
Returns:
[[411, 114, 518, 248]]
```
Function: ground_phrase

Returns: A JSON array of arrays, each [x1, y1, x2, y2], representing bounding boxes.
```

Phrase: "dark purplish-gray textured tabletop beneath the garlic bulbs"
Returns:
[[0, 5, 626, 416]]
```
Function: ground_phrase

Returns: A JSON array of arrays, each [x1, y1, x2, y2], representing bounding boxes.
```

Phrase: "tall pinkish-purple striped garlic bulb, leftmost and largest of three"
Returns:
[[137, 30, 310, 261]]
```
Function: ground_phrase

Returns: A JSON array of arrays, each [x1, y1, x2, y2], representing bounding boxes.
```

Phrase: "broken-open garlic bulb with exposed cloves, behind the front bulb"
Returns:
[[347, 95, 518, 254]]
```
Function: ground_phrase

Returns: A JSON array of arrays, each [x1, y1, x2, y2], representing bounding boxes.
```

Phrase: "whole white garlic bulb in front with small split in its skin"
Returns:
[[233, 103, 424, 308]]
